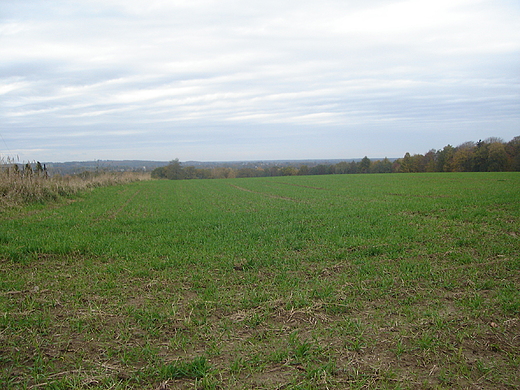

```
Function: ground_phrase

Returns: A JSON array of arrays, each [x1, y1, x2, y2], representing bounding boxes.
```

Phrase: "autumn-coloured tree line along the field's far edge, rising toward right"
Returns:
[[152, 136, 520, 180]]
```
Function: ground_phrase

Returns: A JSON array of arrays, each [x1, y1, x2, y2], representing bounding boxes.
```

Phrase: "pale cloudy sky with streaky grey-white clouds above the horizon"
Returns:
[[0, 0, 520, 162]]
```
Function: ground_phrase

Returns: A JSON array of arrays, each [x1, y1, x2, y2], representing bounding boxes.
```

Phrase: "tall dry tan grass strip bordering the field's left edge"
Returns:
[[0, 160, 150, 210]]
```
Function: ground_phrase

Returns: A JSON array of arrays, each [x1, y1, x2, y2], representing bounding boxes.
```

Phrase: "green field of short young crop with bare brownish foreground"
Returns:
[[0, 173, 520, 390]]
